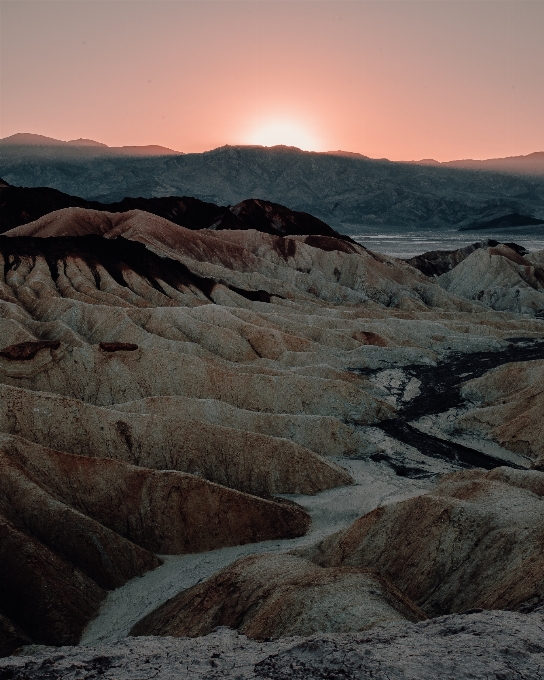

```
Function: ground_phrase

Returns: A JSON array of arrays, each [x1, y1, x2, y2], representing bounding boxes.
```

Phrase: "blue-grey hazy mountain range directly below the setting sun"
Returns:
[[0, 138, 544, 233]]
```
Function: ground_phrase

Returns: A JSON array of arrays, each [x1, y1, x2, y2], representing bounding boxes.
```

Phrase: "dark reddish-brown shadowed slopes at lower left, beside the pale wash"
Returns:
[[0, 435, 309, 653]]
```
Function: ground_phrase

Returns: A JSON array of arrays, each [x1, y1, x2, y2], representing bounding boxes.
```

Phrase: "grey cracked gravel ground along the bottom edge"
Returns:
[[0, 608, 544, 680]]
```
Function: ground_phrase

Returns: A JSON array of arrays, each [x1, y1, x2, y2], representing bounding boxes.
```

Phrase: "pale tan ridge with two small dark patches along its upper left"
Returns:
[[0, 344, 388, 424]]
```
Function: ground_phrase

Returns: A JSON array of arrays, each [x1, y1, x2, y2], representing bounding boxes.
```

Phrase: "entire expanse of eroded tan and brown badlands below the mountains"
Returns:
[[0, 189, 544, 680]]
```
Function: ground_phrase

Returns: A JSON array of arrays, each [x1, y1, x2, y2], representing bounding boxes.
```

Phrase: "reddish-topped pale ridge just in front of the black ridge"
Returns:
[[1, 208, 488, 311]]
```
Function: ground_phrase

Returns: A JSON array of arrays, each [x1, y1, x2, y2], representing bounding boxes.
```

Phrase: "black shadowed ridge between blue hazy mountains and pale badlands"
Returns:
[[0, 179, 351, 241]]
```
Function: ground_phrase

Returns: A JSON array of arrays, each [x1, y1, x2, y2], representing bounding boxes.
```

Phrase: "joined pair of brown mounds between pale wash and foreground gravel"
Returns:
[[131, 467, 544, 639]]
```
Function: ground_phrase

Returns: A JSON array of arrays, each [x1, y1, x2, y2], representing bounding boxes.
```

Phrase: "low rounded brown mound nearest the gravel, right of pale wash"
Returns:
[[131, 555, 425, 640]]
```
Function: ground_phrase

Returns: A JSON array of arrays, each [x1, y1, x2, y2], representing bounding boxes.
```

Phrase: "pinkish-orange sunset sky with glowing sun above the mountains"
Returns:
[[0, 0, 544, 161]]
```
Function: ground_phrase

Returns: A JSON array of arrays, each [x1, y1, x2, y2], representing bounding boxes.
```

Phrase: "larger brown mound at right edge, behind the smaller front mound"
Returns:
[[297, 468, 544, 616]]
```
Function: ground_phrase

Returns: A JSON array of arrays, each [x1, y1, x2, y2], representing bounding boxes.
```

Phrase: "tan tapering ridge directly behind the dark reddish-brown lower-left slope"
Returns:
[[0, 385, 351, 495]]
